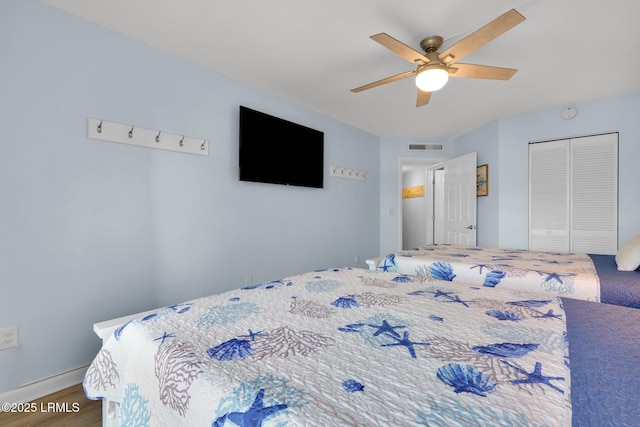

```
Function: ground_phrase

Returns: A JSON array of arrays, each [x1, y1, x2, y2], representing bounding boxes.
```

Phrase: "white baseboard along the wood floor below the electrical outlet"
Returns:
[[0, 365, 89, 412]]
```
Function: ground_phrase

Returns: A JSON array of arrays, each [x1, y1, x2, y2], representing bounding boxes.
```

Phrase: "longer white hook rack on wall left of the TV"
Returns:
[[87, 118, 209, 156]]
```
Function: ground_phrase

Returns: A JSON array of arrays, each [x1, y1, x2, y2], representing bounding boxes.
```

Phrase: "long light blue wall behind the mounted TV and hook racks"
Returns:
[[0, 0, 380, 393]]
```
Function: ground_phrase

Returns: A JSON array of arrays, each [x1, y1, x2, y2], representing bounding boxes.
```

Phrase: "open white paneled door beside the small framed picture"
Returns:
[[444, 153, 477, 246]]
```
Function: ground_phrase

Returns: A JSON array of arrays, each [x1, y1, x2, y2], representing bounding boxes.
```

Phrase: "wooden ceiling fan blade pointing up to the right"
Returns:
[[440, 9, 525, 64]]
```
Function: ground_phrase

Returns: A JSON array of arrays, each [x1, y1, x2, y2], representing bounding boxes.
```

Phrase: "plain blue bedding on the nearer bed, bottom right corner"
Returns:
[[562, 298, 640, 427]]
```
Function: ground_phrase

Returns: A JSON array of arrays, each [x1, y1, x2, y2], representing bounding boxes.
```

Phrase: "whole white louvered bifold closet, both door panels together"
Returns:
[[529, 133, 618, 254]]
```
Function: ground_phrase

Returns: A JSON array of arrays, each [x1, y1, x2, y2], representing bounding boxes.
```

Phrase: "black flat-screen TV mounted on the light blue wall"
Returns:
[[239, 106, 324, 188]]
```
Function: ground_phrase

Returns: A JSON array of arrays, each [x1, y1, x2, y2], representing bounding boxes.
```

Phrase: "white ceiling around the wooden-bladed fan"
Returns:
[[43, 0, 640, 138]]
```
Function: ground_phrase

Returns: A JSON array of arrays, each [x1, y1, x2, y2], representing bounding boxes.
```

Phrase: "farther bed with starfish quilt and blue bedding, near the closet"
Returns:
[[367, 245, 640, 308]]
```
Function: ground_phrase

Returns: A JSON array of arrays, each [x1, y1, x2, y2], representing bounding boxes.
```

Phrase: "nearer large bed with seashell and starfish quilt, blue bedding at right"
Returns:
[[83, 268, 640, 427]]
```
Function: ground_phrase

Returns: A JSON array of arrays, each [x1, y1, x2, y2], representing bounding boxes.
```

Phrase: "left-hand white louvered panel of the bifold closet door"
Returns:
[[529, 141, 569, 252]]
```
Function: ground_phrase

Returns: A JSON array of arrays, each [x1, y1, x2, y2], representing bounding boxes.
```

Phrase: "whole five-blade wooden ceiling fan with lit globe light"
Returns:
[[351, 9, 525, 107]]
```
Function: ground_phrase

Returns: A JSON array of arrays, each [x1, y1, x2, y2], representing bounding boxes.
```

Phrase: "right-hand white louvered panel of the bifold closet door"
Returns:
[[569, 133, 618, 254]]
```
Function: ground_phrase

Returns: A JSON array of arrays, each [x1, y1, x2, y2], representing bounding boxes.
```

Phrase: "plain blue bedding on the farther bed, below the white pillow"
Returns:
[[589, 254, 640, 308]]
